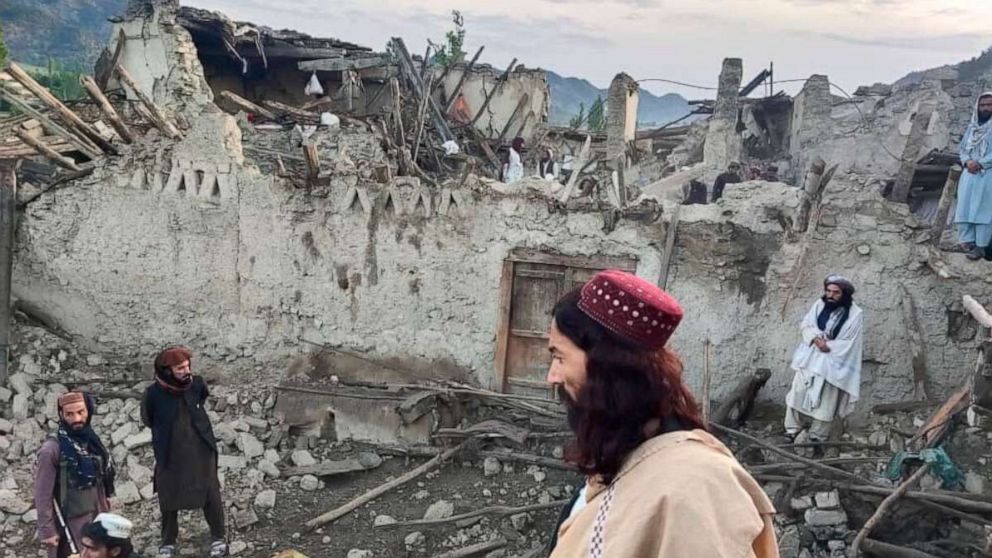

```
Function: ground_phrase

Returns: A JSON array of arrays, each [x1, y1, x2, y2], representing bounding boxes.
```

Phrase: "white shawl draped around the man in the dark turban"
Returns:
[[792, 299, 864, 416]]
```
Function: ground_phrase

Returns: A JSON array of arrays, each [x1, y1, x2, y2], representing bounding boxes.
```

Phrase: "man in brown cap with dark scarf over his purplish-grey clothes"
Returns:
[[34, 391, 115, 558]]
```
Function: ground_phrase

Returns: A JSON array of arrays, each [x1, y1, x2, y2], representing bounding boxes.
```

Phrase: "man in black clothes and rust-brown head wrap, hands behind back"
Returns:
[[141, 347, 227, 558]]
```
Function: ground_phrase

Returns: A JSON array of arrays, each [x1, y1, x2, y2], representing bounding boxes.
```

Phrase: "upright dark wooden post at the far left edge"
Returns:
[[0, 160, 18, 385]]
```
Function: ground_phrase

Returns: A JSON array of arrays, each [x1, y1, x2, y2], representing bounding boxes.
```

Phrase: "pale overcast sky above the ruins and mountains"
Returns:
[[188, 0, 992, 98]]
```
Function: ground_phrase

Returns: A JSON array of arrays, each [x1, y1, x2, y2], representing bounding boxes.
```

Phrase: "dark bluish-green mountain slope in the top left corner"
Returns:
[[0, 0, 127, 71]]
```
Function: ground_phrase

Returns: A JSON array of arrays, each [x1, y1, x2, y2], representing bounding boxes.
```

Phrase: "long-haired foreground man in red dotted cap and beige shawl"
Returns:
[[548, 270, 778, 558]]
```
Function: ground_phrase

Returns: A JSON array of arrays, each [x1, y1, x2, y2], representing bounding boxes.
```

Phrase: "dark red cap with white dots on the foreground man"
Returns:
[[579, 269, 683, 349]]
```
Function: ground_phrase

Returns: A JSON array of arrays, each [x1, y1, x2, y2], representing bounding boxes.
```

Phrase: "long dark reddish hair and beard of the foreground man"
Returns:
[[554, 289, 705, 484]]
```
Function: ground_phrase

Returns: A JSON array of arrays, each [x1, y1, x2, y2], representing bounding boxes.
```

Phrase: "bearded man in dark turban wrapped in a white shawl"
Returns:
[[785, 275, 864, 442]]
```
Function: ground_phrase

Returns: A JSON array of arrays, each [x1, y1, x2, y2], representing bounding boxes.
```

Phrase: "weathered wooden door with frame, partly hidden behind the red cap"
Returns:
[[496, 250, 636, 398]]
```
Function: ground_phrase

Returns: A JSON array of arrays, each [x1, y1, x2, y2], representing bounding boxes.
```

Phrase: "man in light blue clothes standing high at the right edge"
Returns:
[[954, 92, 992, 260]]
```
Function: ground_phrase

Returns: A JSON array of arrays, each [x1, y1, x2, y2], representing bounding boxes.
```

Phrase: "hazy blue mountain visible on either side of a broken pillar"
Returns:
[[548, 71, 690, 127]]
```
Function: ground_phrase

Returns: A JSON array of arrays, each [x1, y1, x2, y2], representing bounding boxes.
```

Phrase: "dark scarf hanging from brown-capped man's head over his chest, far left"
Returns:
[[57, 394, 117, 498]]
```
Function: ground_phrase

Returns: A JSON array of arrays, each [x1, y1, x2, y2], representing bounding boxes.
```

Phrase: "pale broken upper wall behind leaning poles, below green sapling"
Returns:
[[439, 65, 551, 142]]
